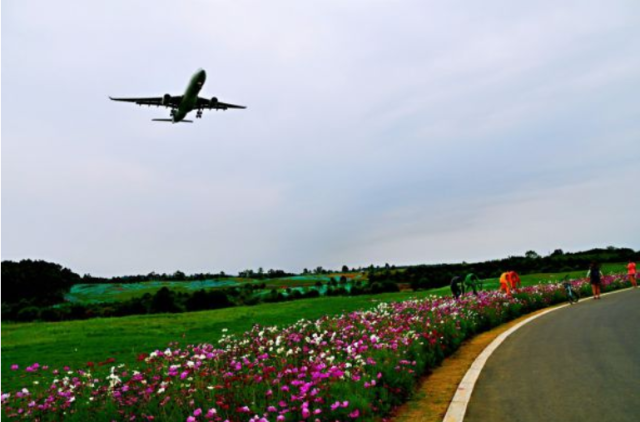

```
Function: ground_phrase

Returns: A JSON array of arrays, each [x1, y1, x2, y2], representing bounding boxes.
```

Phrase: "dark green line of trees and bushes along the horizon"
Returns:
[[2, 247, 640, 321]]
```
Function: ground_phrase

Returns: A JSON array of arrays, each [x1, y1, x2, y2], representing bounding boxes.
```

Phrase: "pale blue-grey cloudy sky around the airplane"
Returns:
[[1, 0, 640, 276]]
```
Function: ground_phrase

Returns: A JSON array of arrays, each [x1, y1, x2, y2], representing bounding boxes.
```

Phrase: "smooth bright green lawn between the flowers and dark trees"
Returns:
[[2, 264, 625, 391]]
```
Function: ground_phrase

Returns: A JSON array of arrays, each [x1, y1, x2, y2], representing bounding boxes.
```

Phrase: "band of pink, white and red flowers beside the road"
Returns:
[[2, 276, 627, 422]]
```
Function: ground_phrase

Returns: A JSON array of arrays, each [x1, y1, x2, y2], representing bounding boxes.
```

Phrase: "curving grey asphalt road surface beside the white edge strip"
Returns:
[[464, 289, 640, 422]]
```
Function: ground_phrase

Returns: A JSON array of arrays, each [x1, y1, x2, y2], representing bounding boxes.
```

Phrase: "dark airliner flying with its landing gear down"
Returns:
[[109, 69, 246, 123]]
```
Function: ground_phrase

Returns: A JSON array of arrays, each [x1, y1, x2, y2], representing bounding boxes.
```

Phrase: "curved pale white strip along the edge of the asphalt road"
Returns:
[[443, 287, 633, 422]]
